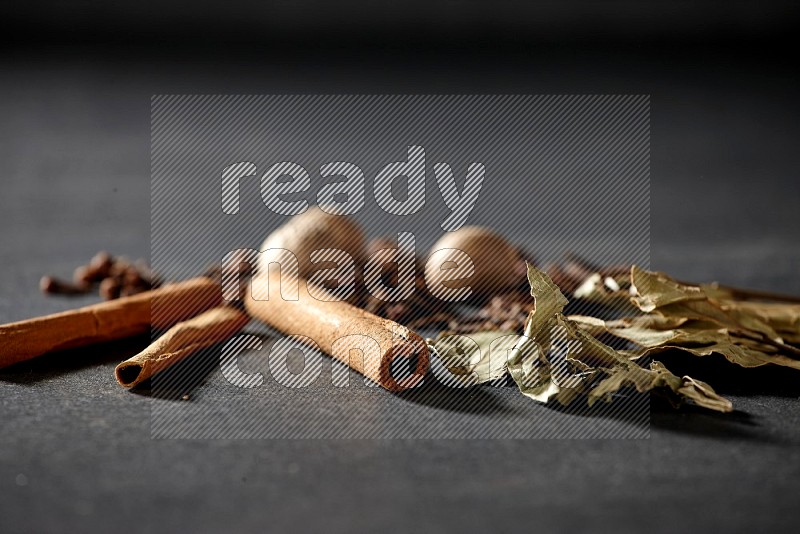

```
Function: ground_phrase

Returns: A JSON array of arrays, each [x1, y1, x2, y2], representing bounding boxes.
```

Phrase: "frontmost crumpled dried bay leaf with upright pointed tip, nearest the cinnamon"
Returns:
[[434, 265, 731, 411]]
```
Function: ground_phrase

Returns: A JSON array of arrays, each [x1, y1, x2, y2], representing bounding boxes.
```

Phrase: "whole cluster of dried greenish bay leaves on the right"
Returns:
[[430, 265, 800, 412]]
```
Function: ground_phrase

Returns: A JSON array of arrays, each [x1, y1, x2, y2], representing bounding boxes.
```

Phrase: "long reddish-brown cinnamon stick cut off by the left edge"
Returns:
[[0, 277, 222, 368]]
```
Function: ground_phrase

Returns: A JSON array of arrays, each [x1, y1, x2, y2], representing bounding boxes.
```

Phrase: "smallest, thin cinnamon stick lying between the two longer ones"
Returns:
[[114, 307, 250, 388]]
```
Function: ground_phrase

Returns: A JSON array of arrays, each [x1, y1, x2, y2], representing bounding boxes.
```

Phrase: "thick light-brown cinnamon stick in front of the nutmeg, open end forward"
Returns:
[[245, 272, 430, 391]]
